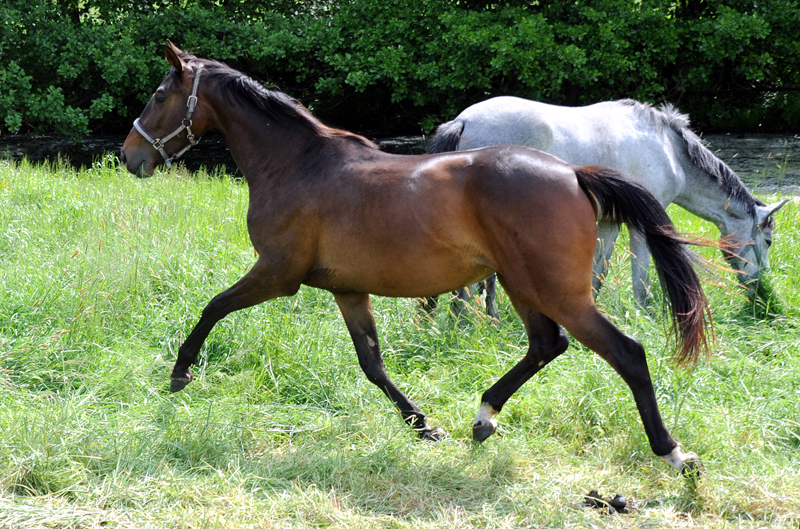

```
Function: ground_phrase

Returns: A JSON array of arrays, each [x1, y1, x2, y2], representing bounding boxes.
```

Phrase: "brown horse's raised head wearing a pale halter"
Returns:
[[120, 41, 212, 177]]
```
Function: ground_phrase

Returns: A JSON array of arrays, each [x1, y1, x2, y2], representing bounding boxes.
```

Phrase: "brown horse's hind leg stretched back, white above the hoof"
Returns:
[[562, 305, 700, 472]]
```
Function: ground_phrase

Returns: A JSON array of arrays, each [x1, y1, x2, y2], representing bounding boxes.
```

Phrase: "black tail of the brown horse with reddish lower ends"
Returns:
[[575, 166, 711, 365]]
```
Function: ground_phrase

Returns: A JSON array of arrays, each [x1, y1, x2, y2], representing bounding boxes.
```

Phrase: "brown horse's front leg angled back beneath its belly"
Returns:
[[333, 293, 445, 440]]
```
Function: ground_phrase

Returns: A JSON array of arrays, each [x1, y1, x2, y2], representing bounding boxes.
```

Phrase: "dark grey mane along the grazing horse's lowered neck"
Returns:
[[619, 99, 764, 210]]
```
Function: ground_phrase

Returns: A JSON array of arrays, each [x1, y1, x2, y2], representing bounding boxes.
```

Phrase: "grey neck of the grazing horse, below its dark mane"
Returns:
[[674, 160, 753, 237]]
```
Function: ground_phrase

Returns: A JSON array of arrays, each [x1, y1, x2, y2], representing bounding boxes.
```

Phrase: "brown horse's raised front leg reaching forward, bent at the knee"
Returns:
[[170, 259, 300, 393]]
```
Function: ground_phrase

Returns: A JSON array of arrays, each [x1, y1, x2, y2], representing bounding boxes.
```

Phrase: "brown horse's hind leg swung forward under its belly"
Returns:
[[472, 298, 569, 442]]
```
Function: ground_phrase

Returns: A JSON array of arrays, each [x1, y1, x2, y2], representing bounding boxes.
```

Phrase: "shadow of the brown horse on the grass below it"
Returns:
[[153, 422, 525, 520]]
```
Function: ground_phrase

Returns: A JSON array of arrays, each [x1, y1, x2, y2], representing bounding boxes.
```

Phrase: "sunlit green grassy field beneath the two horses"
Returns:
[[0, 161, 800, 529]]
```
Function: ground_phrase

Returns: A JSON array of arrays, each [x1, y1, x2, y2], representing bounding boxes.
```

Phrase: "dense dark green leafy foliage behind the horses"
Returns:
[[0, 0, 800, 134]]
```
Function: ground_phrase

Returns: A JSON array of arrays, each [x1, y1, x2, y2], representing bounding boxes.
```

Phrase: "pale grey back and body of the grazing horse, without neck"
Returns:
[[454, 96, 685, 205]]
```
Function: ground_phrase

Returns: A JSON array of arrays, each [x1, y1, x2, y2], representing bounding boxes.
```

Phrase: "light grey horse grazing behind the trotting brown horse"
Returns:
[[429, 96, 788, 318]]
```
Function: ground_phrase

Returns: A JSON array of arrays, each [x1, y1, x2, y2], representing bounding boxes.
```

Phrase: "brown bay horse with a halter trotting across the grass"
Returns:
[[120, 43, 708, 470]]
